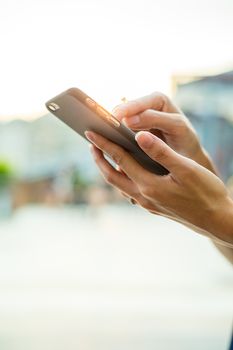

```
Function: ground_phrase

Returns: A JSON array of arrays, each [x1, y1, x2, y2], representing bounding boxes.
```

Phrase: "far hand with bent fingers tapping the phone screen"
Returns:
[[113, 92, 216, 173]]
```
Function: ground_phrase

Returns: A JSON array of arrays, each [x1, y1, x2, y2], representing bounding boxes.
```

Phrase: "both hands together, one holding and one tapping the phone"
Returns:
[[86, 93, 233, 247]]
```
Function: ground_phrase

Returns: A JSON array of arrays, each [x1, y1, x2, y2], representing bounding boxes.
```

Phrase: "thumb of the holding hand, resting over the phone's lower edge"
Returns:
[[135, 131, 187, 176]]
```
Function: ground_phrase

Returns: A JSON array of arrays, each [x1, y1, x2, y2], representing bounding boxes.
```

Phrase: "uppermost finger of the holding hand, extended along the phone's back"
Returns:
[[85, 131, 150, 184]]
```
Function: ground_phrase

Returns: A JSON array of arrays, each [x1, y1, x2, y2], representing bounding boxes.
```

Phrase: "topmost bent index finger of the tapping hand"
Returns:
[[112, 92, 180, 120]]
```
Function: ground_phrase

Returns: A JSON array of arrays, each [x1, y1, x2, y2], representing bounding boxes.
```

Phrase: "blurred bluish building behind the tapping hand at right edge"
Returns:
[[172, 71, 233, 180]]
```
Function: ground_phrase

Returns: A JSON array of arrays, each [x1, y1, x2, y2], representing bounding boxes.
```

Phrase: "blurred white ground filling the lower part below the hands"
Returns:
[[0, 206, 233, 350]]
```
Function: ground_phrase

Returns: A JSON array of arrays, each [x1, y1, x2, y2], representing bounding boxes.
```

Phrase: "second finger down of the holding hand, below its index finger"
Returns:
[[91, 145, 141, 197]]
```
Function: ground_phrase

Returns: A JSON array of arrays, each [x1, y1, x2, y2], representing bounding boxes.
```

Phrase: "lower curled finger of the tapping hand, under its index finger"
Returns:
[[123, 109, 184, 133]]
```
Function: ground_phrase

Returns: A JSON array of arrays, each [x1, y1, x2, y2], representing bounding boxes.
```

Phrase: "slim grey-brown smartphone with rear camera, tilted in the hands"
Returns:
[[46, 88, 168, 175]]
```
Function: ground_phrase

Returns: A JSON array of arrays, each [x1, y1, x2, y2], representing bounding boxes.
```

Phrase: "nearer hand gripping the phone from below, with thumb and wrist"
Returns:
[[86, 131, 233, 247]]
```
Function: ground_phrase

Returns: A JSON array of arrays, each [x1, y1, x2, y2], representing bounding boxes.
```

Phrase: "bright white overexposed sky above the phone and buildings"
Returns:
[[0, 0, 233, 119]]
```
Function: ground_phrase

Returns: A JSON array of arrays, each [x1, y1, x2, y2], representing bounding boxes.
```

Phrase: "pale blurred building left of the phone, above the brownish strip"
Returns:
[[0, 114, 96, 179]]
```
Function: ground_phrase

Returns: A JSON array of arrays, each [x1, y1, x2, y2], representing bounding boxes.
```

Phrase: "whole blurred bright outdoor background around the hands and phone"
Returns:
[[0, 0, 233, 350]]
